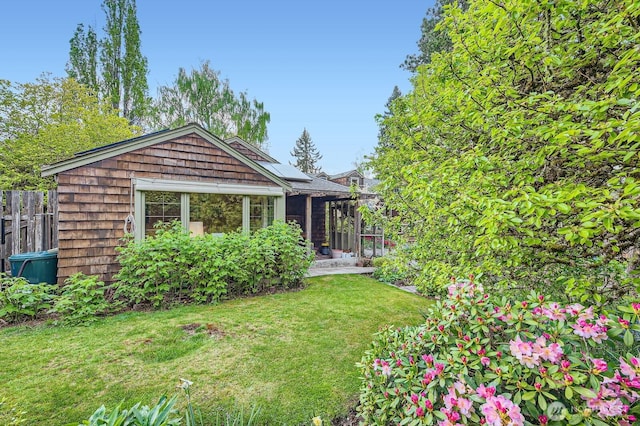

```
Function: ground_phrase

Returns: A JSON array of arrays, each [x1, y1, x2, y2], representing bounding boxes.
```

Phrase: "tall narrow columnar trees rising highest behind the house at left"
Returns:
[[67, 0, 149, 124]]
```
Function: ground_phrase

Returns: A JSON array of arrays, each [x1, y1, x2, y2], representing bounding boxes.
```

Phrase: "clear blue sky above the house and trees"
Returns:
[[0, 0, 433, 173]]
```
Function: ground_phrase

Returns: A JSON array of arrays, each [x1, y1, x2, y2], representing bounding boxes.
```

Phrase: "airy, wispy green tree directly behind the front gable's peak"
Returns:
[[148, 61, 271, 146]]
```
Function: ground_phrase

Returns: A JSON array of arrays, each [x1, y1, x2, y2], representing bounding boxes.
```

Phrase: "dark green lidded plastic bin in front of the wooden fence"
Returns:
[[9, 249, 58, 284]]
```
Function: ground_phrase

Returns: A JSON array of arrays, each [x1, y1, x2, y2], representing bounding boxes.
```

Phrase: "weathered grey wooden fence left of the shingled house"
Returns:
[[0, 191, 58, 272]]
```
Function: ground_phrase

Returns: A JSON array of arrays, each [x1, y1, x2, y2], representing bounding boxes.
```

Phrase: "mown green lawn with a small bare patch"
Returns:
[[0, 275, 430, 425]]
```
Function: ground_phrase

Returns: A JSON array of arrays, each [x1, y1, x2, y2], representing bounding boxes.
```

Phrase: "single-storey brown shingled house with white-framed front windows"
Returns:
[[42, 124, 360, 282]]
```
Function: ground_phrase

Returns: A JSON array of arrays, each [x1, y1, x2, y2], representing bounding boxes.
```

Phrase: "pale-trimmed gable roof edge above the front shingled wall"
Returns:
[[42, 124, 291, 190]]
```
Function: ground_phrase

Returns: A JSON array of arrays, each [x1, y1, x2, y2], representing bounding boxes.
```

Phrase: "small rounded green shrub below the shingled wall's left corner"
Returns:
[[51, 272, 111, 324]]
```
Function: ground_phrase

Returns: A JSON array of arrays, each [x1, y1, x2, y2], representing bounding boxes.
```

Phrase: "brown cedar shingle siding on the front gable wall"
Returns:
[[57, 133, 280, 283]]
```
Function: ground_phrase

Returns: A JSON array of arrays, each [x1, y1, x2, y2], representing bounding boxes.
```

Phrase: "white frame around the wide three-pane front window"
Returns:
[[133, 178, 286, 241]]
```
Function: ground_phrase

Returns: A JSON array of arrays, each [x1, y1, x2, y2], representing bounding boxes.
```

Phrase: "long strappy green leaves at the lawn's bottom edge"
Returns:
[[77, 396, 182, 426]]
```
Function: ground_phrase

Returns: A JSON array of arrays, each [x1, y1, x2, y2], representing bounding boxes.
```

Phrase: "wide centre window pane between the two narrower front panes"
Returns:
[[189, 194, 242, 234]]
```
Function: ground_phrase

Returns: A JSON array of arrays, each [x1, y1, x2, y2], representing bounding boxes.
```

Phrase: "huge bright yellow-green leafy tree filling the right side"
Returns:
[[371, 0, 640, 304]]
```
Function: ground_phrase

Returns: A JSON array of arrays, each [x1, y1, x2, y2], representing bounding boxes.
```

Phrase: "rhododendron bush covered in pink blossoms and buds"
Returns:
[[359, 280, 640, 426]]
